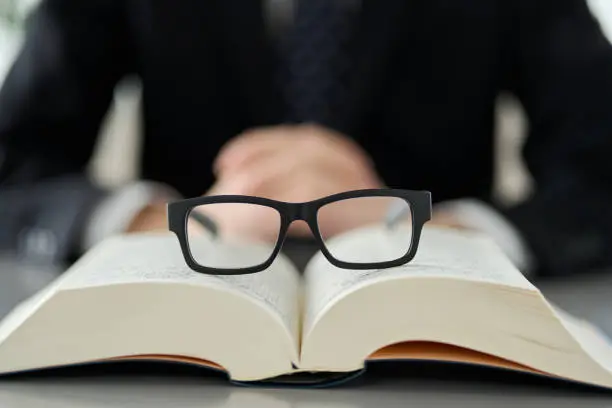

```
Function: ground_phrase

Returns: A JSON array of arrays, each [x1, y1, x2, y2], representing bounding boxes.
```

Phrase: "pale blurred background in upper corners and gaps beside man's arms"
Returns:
[[0, 0, 612, 203]]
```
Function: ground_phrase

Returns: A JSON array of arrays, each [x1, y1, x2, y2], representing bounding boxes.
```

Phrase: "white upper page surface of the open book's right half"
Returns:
[[304, 226, 537, 332]]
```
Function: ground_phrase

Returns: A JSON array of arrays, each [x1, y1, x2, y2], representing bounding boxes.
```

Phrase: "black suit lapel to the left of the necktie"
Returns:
[[215, 0, 283, 126]]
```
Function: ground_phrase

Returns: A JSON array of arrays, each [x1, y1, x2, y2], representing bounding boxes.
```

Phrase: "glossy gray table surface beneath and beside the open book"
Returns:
[[0, 257, 612, 408]]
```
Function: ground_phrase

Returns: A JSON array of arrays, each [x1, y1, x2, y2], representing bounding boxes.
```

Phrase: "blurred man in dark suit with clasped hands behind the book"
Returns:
[[0, 0, 612, 274]]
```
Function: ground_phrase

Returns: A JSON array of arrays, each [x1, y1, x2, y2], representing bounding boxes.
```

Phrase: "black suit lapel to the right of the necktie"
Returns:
[[340, 0, 411, 134]]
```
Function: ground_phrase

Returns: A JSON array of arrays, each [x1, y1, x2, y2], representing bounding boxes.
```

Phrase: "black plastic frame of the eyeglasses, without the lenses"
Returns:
[[167, 188, 432, 275]]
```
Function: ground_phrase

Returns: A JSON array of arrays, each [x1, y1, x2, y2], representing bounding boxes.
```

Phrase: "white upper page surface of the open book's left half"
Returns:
[[56, 234, 300, 336]]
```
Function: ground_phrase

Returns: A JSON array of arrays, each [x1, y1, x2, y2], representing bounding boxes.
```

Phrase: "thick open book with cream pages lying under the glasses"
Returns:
[[0, 228, 612, 387]]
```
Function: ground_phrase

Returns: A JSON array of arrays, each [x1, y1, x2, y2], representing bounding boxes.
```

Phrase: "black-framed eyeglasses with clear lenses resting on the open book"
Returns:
[[168, 189, 431, 275]]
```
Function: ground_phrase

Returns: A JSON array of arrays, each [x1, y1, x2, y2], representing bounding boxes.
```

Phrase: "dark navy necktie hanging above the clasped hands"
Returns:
[[283, 0, 354, 126]]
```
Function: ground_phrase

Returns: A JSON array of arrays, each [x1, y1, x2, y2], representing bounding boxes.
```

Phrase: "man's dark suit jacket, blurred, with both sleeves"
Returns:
[[0, 0, 612, 273]]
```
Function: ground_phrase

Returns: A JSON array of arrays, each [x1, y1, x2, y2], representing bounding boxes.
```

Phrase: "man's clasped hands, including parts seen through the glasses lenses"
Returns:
[[208, 125, 383, 238]]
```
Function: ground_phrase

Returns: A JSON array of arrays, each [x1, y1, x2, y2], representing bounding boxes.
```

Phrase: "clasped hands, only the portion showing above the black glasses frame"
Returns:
[[213, 125, 381, 201]]
